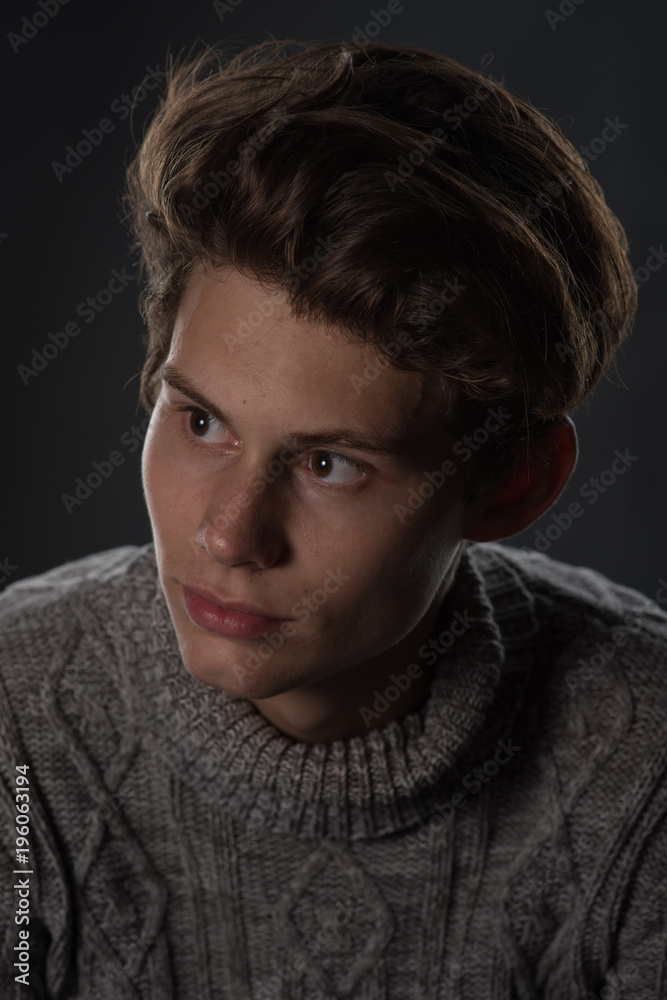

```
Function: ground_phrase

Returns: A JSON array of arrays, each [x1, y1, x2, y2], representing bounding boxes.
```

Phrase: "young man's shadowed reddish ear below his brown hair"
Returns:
[[462, 416, 579, 542]]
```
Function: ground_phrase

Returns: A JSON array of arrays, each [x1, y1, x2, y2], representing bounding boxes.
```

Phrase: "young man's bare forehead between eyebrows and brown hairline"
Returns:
[[169, 269, 456, 453]]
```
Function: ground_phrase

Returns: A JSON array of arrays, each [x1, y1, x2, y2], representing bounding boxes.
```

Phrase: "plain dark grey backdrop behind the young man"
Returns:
[[0, 0, 667, 596]]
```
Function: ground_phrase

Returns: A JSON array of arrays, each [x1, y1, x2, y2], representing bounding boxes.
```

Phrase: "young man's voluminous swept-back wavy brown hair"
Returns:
[[125, 40, 637, 500]]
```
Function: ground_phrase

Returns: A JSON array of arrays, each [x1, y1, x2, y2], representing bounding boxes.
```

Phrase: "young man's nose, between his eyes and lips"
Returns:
[[196, 462, 286, 569]]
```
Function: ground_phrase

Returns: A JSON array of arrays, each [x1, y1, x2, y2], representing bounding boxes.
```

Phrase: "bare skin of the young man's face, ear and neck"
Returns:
[[142, 269, 577, 743]]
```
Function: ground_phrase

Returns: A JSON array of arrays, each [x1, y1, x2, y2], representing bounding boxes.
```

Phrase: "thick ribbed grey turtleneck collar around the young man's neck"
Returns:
[[128, 544, 537, 840]]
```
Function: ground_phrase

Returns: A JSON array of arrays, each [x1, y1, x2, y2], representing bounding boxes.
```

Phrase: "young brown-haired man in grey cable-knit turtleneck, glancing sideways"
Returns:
[[0, 37, 667, 1000]]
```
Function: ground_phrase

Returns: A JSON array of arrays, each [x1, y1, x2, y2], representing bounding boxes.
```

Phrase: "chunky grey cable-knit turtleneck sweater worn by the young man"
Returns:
[[0, 543, 667, 1000]]
